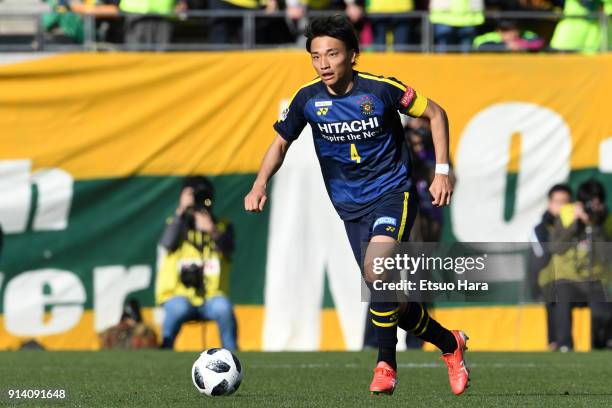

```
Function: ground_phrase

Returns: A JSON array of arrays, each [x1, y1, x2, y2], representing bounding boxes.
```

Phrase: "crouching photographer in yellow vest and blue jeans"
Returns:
[[155, 176, 237, 350]]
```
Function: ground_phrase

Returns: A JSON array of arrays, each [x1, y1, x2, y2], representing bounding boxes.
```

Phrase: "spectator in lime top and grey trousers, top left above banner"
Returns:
[[119, 0, 187, 51]]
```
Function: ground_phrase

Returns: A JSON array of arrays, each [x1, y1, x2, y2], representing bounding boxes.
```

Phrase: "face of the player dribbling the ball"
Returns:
[[310, 36, 356, 87]]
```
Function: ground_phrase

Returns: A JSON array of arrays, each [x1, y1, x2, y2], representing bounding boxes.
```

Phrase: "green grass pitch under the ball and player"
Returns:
[[0, 351, 612, 408]]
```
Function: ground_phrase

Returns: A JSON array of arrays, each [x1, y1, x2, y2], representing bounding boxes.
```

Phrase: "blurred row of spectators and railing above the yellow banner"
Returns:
[[0, 0, 612, 53]]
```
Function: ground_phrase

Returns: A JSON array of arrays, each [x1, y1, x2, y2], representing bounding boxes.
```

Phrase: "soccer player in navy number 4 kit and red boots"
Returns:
[[244, 15, 469, 395]]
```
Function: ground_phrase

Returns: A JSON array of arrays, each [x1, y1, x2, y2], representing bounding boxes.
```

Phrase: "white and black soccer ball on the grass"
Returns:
[[191, 348, 242, 397]]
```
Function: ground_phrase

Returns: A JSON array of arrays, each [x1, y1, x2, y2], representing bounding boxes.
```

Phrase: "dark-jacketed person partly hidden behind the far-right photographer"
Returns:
[[527, 184, 572, 350]]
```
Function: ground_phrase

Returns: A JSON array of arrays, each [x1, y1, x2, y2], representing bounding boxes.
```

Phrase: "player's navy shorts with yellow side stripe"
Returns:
[[344, 191, 418, 267]]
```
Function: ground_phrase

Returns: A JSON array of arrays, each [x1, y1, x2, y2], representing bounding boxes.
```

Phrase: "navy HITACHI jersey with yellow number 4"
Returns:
[[274, 71, 427, 220]]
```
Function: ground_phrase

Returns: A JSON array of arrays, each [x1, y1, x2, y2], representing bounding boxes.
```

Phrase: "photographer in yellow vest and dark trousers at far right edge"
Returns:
[[538, 180, 612, 351]]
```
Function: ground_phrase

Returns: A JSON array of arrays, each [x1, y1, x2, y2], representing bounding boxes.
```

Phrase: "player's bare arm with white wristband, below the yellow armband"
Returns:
[[423, 99, 453, 207]]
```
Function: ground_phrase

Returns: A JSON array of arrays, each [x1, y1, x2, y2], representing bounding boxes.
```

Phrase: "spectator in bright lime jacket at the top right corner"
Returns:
[[550, 0, 612, 53]]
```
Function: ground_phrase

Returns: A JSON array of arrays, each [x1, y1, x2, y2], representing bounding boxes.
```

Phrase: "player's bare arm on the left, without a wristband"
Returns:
[[244, 135, 291, 212]]
